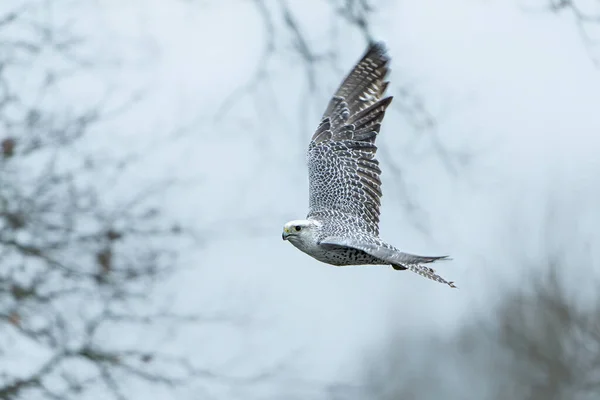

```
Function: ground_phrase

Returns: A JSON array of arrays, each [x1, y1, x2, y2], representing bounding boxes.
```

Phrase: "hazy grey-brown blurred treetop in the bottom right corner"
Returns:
[[362, 262, 600, 400]]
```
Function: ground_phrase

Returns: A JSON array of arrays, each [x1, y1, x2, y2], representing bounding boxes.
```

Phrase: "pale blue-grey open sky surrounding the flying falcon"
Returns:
[[17, 0, 600, 398]]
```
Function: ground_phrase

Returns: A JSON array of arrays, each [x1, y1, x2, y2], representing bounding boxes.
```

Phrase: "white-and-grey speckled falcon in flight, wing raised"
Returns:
[[282, 43, 455, 287]]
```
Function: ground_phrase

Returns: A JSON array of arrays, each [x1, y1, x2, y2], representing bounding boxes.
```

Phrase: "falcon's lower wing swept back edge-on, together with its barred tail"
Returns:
[[319, 237, 456, 288]]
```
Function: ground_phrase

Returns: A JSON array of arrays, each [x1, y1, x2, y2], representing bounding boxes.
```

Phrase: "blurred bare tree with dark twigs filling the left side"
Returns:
[[0, 2, 251, 400]]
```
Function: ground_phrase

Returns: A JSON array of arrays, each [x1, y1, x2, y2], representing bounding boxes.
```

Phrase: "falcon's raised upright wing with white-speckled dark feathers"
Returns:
[[307, 43, 392, 235]]
